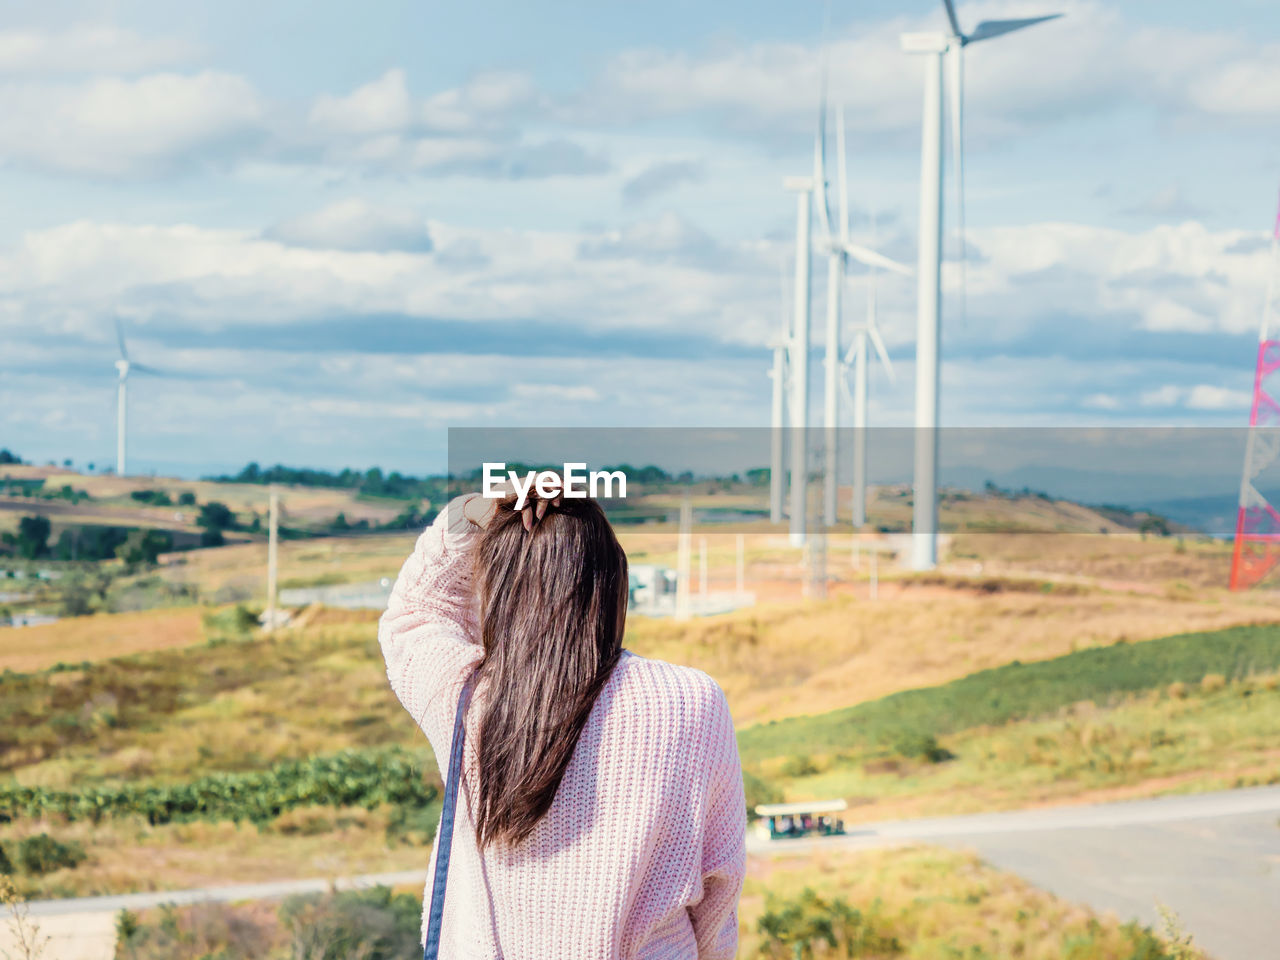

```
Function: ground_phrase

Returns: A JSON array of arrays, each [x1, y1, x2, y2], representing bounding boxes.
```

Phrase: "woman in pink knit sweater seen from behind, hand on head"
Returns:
[[379, 494, 746, 960]]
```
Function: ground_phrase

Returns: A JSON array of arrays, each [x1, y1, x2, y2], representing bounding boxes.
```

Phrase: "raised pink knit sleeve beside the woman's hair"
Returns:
[[378, 494, 484, 764]]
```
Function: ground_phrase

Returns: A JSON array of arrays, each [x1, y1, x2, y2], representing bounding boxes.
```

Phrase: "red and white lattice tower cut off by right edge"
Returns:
[[1231, 190, 1280, 590]]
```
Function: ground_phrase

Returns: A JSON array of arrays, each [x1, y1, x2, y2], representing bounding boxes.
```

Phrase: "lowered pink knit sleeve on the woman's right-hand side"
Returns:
[[689, 686, 746, 960]]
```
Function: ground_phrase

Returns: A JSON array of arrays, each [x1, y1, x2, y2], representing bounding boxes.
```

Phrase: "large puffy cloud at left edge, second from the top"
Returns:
[[0, 72, 265, 178]]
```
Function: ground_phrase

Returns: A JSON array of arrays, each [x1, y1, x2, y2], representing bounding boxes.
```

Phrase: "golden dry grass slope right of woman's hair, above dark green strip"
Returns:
[[628, 581, 1280, 726]]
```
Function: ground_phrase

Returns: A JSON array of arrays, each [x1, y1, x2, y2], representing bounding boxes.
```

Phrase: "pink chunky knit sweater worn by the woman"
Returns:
[[379, 494, 746, 960]]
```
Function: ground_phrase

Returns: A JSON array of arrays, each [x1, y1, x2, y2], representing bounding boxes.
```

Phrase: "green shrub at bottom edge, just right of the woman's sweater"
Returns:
[[755, 887, 902, 960]]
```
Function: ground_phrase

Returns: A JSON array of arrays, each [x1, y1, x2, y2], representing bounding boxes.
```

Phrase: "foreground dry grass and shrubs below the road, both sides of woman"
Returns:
[[74, 837, 1202, 960]]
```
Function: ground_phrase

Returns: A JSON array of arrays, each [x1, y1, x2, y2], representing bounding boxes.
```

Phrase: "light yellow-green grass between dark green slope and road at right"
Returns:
[[758, 673, 1280, 823]]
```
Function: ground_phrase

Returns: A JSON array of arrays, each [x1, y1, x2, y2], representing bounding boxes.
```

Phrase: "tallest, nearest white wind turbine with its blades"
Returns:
[[902, 0, 1061, 570]]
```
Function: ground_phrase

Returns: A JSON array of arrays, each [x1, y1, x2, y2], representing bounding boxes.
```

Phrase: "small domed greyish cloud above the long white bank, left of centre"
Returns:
[[264, 198, 431, 252]]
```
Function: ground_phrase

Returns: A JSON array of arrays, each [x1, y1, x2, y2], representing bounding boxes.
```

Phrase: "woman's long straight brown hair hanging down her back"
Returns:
[[476, 499, 627, 847]]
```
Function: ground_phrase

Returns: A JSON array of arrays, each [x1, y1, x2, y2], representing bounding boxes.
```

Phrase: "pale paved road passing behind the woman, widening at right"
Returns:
[[12, 787, 1280, 960]]
